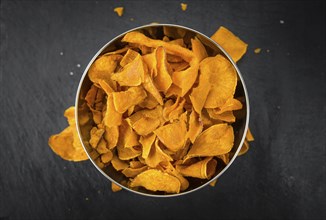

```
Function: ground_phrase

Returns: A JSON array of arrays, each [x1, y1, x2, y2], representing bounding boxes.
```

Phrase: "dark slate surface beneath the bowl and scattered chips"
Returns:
[[0, 0, 326, 219]]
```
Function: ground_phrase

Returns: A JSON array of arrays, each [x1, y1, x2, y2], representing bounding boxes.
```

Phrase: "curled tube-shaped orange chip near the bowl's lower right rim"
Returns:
[[176, 157, 217, 179]]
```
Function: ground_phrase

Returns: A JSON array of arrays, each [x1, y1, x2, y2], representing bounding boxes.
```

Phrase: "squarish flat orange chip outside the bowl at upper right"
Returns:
[[211, 26, 248, 62]]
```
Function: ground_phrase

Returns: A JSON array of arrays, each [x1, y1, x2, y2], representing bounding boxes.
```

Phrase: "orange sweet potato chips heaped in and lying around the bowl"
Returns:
[[49, 27, 253, 193]]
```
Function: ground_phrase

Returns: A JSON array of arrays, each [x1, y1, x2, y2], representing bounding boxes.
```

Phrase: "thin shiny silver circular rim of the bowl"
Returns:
[[75, 23, 250, 198]]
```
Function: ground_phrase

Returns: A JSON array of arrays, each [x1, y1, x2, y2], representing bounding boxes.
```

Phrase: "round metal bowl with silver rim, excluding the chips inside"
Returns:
[[75, 24, 249, 197]]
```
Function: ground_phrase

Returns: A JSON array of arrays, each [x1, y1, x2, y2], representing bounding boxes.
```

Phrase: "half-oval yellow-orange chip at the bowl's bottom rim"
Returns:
[[130, 169, 181, 193]]
